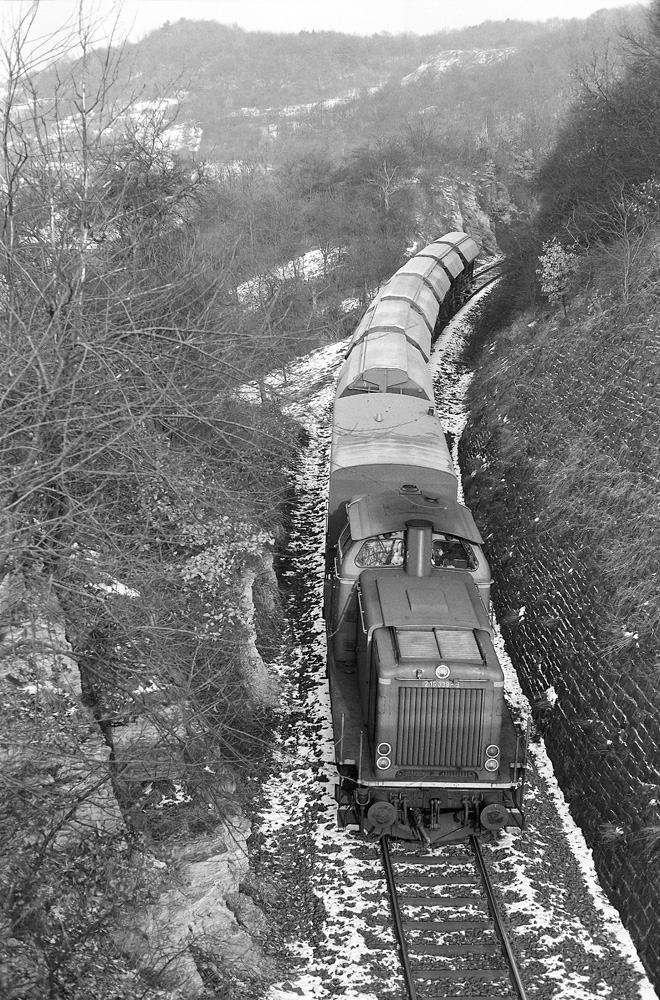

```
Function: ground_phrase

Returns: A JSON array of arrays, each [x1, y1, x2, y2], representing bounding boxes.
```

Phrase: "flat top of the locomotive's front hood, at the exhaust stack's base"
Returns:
[[360, 569, 489, 629]]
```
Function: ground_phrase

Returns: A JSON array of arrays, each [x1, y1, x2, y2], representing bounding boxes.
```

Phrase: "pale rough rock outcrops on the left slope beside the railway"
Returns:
[[0, 552, 279, 1000]]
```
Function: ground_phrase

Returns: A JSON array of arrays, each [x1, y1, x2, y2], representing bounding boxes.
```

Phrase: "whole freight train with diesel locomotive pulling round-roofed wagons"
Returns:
[[323, 232, 526, 846]]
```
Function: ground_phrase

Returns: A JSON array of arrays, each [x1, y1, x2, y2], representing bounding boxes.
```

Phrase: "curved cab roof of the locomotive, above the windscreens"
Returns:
[[348, 492, 483, 545]]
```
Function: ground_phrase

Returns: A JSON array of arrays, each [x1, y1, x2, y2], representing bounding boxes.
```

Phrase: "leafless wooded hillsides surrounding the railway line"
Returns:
[[0, 0, 660, 1000]]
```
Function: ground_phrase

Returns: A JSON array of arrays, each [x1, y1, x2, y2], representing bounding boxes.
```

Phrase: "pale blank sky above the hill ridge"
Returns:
[[0, 0, 650, 48]]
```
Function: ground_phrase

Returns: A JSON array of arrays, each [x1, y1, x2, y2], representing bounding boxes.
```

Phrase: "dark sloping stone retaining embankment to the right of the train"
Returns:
[[461, 312, 660, 986]]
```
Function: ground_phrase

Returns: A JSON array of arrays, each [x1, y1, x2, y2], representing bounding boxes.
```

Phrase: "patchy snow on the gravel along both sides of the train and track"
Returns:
[[254, 301, 657, 1000]]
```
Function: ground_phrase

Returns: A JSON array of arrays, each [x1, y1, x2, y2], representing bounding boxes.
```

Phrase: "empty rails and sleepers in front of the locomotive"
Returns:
[[366, 837, 526, 1000]]
